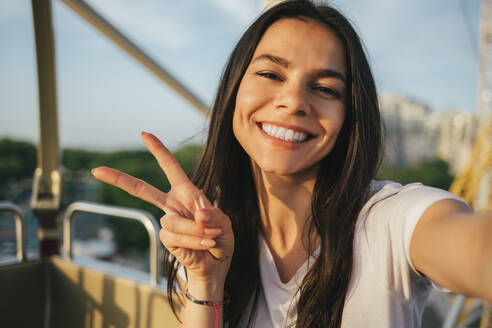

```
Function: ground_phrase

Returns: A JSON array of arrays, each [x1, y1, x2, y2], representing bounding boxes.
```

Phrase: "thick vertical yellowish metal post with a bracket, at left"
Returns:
[[31, 0, 62, 257]]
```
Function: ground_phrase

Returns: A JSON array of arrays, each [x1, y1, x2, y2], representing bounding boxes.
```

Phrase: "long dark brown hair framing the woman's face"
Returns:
[[166, 0, 381, 327]]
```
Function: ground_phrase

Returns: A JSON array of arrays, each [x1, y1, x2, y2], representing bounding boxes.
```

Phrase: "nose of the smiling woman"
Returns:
[[274, 80, 311, 116]]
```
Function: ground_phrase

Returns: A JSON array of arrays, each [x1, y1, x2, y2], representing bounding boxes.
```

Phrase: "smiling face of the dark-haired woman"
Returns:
[[233, 19, 346, 178]]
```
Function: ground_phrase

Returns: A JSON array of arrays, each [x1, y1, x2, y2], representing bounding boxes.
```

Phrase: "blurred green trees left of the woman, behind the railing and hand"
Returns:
[[0, 138, 203, 250]]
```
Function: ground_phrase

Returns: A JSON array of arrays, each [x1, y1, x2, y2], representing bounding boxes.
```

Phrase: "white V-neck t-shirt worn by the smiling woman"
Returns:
[[238, 181, 468, 328]]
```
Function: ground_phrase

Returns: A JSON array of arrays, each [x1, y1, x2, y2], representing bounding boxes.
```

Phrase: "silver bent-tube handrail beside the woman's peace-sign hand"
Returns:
[[62, 201, 162, 286]]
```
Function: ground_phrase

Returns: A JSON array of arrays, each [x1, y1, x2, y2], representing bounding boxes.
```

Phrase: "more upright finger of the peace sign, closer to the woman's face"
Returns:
[[142, 132, 191, 186]]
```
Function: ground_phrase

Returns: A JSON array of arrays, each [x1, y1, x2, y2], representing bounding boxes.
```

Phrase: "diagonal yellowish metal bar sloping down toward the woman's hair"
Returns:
[[62, 0, 209, 117]]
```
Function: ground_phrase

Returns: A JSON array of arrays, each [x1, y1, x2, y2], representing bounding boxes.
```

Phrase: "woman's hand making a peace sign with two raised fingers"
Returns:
[[92, 132, 234, 281]]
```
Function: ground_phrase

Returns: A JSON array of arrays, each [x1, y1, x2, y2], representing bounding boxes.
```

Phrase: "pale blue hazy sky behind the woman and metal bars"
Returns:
[[0, 0, 480, 151]]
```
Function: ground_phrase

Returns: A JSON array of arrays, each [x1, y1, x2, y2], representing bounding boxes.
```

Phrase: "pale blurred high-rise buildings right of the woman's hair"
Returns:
[[380, 94, 478, 173]]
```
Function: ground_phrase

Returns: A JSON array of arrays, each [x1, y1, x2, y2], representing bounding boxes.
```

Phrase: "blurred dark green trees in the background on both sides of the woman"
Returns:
[[0, 139, 453, 249]]
